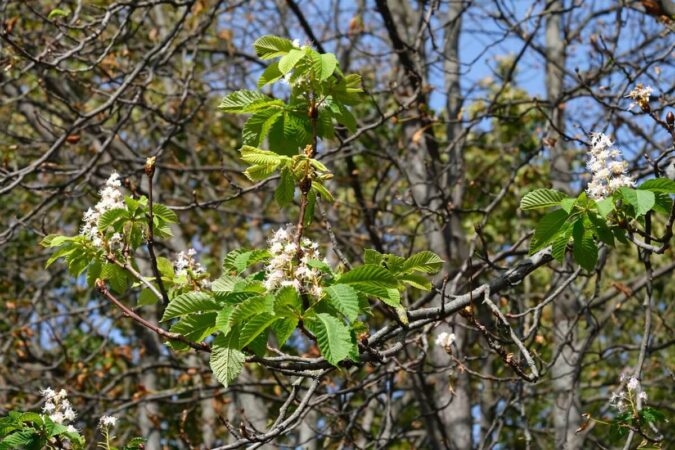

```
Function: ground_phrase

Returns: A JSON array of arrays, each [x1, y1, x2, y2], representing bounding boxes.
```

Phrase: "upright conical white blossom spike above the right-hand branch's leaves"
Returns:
[[586, 133, 635, 200]]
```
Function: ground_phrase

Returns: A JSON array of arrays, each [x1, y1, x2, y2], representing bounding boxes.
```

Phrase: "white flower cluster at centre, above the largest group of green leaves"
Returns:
[[265, 225, 325, 298]]
